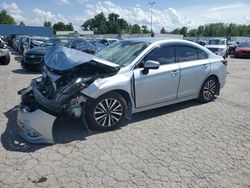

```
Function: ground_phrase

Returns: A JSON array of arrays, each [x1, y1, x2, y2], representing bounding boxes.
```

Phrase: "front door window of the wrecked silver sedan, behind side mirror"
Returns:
[[144, 46, 175, 65]]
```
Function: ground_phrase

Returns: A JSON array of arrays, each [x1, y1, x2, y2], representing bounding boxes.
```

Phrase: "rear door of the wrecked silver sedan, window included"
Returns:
[[175, 45, 211, 98]]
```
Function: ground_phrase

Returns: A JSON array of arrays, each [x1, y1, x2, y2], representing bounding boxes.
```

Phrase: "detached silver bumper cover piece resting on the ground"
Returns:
[[17, 106, 56, 144]]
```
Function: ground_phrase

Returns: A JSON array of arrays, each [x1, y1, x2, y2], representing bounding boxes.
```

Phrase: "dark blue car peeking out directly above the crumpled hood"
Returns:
[[65, 38, 96, 54]]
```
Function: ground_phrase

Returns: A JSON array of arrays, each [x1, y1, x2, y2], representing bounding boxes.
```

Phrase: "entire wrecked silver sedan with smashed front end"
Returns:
[[17, 38, 227, 143]]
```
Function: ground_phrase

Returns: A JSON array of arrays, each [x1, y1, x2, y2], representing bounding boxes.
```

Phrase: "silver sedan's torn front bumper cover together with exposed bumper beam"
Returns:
[[17, 78, 89, 144]]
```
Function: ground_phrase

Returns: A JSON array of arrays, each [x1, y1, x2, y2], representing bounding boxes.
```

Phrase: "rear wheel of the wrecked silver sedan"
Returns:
[[197, 77, 218, 103]]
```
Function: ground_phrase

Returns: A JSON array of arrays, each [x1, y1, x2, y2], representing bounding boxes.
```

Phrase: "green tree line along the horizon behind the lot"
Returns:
[[0, 10, 250, 37]]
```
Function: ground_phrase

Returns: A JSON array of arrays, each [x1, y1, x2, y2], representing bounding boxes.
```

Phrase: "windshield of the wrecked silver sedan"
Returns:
[[95, 41, 149, 67]]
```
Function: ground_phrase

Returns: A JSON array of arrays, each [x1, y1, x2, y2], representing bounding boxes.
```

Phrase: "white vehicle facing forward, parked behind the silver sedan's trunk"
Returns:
[[205, 38, 228, 58]]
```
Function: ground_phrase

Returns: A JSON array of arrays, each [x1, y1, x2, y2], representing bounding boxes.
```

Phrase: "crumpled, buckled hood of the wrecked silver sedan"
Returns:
[[45, 47, 119, 71]]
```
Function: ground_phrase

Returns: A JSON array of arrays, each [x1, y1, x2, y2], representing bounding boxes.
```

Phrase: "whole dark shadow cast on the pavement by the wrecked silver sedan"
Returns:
[[1, 100, 200, 153]]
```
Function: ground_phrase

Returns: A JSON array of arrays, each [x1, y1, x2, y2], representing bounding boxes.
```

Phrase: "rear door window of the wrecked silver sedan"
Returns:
[[176, 46, 198, 62]]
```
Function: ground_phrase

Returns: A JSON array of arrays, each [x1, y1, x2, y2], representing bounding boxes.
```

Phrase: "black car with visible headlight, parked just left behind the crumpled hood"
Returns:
[[21, 38, 70, 71]]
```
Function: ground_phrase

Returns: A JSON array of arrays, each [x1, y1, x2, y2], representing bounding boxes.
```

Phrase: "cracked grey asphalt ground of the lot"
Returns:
[[0, 49, 250, 188]]
